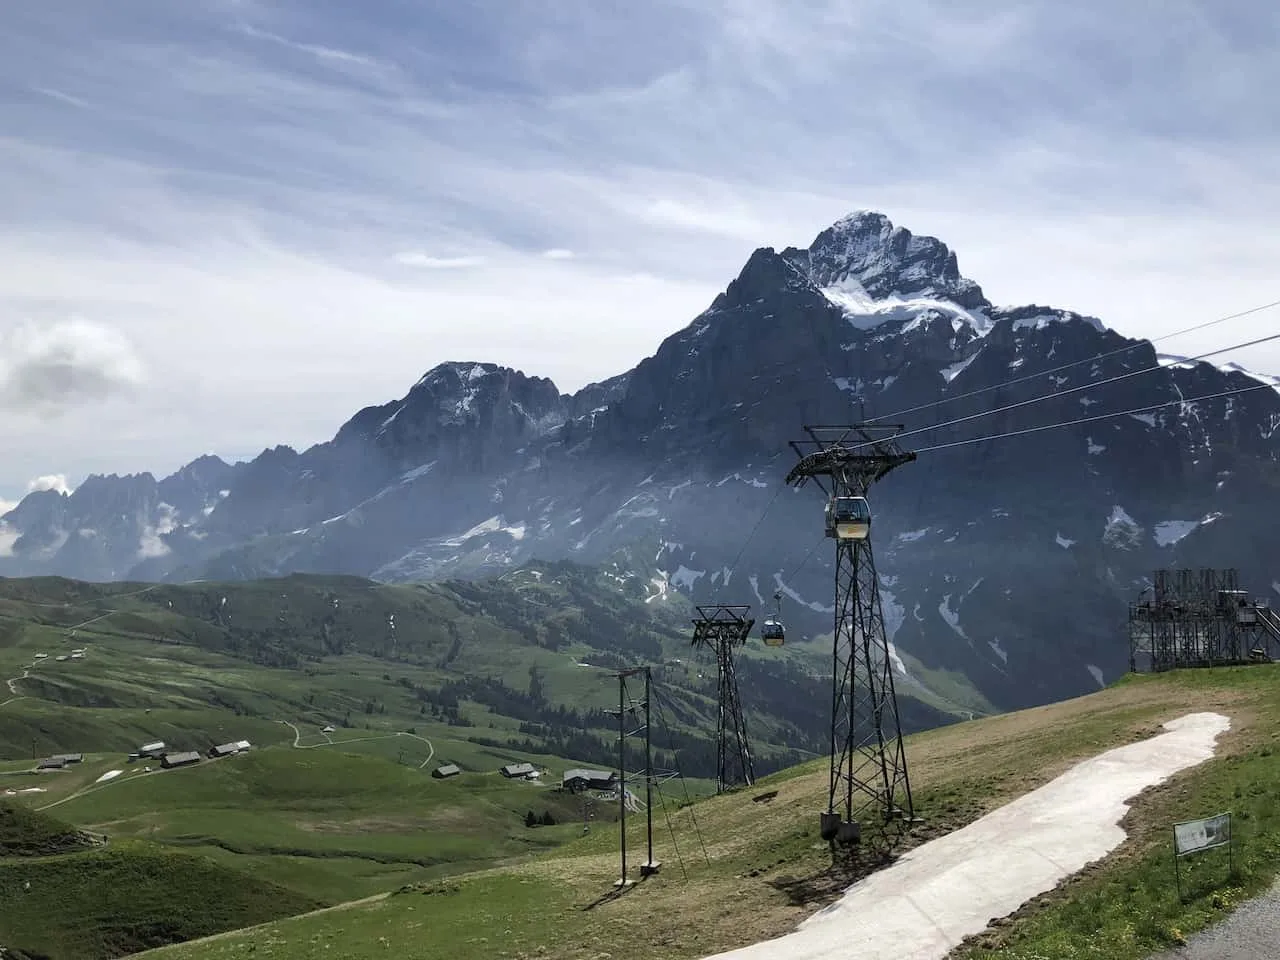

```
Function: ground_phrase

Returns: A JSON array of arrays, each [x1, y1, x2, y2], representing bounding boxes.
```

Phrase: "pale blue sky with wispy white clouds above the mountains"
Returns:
[[0, 0, 1280, 512]]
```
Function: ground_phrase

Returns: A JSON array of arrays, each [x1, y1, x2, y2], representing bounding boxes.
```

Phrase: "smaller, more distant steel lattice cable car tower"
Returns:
[[694, 605, 755, 794]]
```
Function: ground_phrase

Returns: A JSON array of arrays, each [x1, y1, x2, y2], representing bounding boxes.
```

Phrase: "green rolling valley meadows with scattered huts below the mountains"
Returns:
[[0, 563, 954, 960]]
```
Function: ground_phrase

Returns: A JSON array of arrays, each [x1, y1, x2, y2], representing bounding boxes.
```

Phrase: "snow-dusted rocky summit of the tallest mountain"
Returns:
[[782, 210, 991, 310]]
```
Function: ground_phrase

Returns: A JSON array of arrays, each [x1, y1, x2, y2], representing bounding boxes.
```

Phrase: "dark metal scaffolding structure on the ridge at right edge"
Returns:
[[1129, 568, 1280, 673]]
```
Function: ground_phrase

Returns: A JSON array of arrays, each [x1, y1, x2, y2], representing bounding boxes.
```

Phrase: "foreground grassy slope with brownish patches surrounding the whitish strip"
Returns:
[[140, 667, 1280, 960]]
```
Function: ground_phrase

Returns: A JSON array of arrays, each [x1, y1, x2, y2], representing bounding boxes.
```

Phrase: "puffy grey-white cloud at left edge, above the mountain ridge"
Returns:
[[0, 320, 142, 416]]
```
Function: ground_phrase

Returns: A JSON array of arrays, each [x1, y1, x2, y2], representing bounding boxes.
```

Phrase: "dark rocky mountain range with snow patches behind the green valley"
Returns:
[[0, 212, 1280, 712]]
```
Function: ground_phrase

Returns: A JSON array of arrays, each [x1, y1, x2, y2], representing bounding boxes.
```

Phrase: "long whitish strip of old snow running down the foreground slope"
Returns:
[[708, 713, 1231, 960]]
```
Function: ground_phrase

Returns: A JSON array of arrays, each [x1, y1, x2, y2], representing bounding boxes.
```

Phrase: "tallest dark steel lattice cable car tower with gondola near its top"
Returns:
[[786, 424, 915, 852]]
